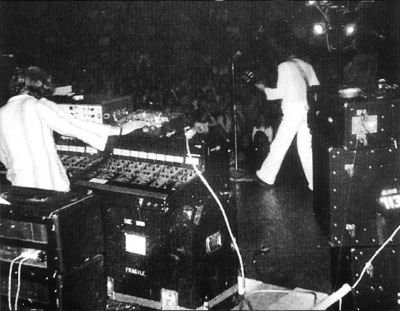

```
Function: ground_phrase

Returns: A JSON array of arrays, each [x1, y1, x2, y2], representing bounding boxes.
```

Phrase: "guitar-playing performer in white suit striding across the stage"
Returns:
[[256, 55, 319, 190]]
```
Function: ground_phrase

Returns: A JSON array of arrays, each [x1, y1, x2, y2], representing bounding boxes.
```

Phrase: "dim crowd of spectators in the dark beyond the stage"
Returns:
[[32, 50, 279, 169]]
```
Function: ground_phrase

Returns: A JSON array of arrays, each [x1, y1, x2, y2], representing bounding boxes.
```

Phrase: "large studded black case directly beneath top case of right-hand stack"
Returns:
[[314, 147, 400, 247]]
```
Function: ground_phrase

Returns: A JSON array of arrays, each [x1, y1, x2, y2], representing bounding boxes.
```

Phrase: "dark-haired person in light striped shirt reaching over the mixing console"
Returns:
[[0, 66, 145, 192]]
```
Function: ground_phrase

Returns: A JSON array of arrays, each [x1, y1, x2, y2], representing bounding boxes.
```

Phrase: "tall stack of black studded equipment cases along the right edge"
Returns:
[[310, 96, 400, 310]]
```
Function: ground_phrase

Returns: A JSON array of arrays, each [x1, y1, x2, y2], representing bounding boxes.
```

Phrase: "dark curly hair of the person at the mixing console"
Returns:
[[10, 66, 54, 99]]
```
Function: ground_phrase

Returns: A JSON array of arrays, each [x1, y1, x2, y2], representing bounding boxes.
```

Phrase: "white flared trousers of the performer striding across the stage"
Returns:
[[257, 109, 313, 190]]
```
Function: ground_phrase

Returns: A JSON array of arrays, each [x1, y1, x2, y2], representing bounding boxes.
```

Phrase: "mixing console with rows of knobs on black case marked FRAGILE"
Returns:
[[57, 106, 238, 308]]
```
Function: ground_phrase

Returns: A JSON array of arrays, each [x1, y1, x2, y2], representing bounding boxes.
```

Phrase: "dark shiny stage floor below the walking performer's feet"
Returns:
[[233, 146, 332, 293]]
